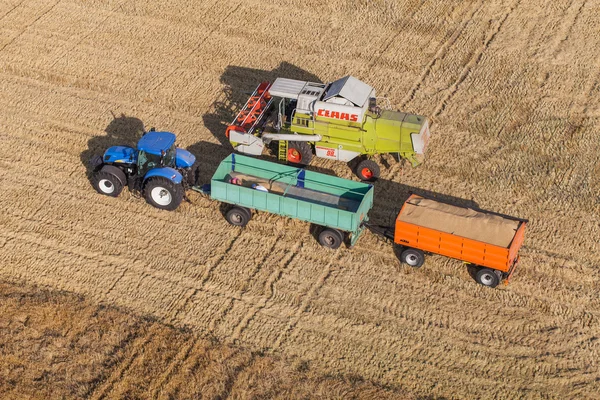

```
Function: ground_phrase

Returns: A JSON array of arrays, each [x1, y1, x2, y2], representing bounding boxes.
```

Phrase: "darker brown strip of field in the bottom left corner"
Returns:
[[0, 282, 404, 399]]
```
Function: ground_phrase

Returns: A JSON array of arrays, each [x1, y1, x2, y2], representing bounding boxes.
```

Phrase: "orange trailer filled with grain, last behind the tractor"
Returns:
[[376, 194, 527, 287]]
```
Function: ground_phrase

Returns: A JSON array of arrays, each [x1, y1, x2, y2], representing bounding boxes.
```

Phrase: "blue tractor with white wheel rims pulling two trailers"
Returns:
[[91, 129, 198, 211]]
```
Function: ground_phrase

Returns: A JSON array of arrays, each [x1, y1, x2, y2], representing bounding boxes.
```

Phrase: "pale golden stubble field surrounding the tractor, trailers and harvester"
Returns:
[[0, 0, 600, 399]]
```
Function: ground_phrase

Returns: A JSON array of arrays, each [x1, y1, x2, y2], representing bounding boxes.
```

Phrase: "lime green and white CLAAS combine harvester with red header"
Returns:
[[226, 76, 430, 181]]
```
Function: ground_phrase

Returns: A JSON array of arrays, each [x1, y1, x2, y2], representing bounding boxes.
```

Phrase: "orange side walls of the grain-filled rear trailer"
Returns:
[[394, 196, 525, 272]]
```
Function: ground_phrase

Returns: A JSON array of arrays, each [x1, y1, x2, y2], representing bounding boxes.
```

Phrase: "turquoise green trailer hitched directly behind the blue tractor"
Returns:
[[195, 154, 373, 248]]
